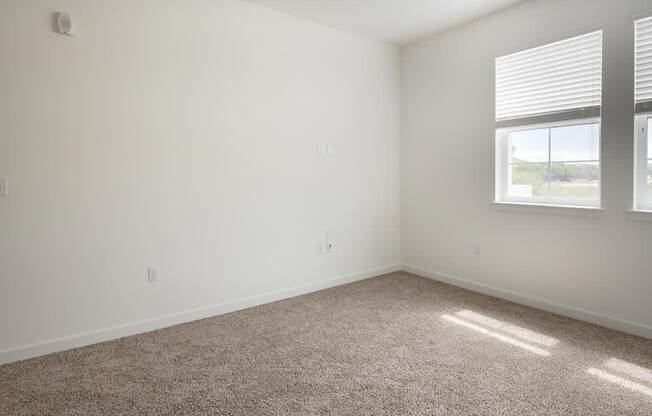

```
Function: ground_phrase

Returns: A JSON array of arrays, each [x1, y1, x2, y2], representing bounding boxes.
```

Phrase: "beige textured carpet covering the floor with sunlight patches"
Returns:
[[0, 273, 652, 416]]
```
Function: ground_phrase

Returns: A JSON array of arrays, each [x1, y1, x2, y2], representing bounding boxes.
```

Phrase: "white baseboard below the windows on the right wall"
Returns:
[[403, 264, 652, 339]]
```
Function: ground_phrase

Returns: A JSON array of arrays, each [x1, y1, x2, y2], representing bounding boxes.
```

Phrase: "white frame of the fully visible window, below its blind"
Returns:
[[495, 114, 604, 209]]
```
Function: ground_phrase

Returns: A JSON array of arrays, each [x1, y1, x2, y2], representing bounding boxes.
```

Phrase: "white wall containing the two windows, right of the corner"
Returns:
[[401, 0, 652, 336]]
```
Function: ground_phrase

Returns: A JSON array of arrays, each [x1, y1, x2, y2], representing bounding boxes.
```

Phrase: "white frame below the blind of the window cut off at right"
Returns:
[[634, 113, 652, 211]]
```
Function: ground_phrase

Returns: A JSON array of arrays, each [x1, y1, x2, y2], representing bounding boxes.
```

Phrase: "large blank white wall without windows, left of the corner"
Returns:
[[0, 0, 400, 361]]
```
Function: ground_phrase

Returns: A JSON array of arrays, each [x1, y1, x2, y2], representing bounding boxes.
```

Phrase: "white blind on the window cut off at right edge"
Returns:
[[635, 17, 652, 113]]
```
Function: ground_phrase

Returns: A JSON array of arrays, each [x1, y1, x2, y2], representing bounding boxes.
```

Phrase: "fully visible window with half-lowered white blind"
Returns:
[[496, 31, 602, 207]]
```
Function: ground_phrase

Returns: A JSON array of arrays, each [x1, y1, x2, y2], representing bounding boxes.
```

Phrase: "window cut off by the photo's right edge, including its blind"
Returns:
[[634, 18, 652, 211]]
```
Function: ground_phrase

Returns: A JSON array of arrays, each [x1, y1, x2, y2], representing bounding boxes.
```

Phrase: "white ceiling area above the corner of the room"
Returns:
[[244, 0, 522, 45]]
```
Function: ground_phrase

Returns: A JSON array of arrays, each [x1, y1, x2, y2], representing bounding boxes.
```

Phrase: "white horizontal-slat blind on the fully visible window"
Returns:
[[496, 31, 600, 127]]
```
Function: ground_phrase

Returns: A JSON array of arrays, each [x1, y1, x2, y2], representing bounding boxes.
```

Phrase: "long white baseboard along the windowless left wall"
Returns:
[[0, 265, 401, 365]]
